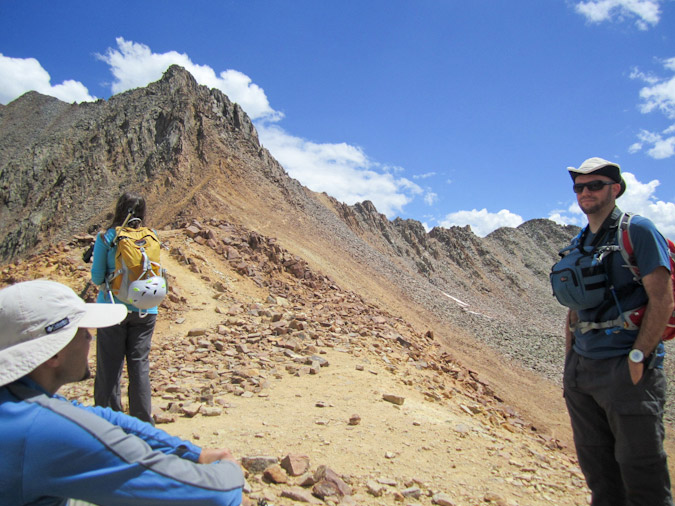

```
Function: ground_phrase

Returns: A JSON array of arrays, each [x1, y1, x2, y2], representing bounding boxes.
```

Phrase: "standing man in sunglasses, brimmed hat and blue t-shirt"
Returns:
[[563, 158, 673, 506]]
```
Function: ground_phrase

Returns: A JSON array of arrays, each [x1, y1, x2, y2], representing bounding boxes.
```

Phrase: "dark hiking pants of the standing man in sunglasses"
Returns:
[[563, 350, 673, 506]]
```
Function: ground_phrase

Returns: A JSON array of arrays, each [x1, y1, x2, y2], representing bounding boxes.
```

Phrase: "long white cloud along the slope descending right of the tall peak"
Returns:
[[256, 122, 423, 218]]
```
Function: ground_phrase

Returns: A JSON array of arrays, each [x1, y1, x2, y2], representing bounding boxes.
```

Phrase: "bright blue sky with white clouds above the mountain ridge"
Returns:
[[0, 0, 675, 238]]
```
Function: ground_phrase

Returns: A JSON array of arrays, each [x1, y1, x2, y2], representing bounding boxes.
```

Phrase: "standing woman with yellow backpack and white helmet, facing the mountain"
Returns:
[[91, 192, 167, 423]]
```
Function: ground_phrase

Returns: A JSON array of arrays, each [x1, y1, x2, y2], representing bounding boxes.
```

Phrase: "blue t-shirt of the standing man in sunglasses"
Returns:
[[574, 210, 670, 359]]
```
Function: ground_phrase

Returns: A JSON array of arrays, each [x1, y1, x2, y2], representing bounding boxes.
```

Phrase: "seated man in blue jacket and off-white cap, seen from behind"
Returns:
[[0, 280, 244, 506]]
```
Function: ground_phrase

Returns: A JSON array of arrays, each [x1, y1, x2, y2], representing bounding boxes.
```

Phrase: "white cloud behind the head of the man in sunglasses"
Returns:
[[549, 172, 675, 238]]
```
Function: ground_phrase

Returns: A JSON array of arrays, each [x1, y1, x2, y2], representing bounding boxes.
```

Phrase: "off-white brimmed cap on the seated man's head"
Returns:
[[0, 280, 127, 386]]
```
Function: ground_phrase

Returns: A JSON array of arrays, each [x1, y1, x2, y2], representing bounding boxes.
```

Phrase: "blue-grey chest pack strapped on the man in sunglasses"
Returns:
[[549, 209, 621, 311]]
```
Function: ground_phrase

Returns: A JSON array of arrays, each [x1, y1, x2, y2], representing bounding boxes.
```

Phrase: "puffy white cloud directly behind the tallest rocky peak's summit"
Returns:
[[97, 37, 283, 121]]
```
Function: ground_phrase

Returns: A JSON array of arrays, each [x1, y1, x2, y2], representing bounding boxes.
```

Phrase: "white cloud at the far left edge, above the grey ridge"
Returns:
[[0, 53, 96, 104]]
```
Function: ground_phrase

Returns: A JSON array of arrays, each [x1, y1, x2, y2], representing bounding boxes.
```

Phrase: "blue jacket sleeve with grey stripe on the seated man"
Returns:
[[23, 396, 244, 506]]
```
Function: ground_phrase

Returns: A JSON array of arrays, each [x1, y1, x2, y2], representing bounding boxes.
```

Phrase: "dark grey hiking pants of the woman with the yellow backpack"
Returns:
[[94, 312, 157, 424]]
